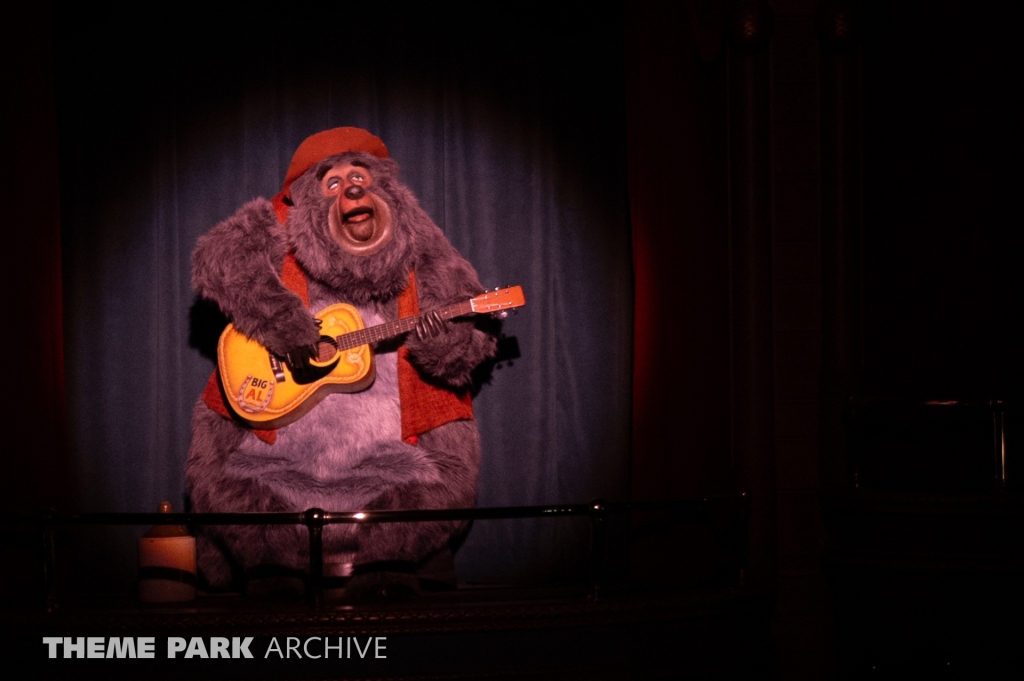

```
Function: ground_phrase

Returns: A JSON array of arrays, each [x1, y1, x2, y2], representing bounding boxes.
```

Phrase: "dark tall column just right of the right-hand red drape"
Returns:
[[726, 0, 777, 586]]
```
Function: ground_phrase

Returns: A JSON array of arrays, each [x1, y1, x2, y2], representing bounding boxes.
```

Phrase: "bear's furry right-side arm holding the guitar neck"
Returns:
[[406, 236, 498, 388]]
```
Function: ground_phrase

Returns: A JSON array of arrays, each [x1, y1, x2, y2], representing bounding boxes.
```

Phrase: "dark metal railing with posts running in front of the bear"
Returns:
[[0, 492, 750, 611]]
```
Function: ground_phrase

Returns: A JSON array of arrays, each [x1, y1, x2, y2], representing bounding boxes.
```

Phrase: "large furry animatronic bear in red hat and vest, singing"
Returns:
[[186, 128, 496, 587]]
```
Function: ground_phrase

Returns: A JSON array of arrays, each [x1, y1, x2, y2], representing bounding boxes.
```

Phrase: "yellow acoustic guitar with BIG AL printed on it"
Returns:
[[217, 286, 526, 428]]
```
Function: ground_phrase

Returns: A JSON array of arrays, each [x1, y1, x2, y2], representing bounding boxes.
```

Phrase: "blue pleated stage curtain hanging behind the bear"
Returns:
[[53, 5, 633, 587]]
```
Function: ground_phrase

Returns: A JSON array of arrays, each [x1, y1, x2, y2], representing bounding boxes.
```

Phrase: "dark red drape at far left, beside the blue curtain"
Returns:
[[0, 2, 67, 511]]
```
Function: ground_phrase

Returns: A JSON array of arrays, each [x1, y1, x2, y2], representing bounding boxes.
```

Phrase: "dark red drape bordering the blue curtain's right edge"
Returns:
[[626, 3, 730, 499]]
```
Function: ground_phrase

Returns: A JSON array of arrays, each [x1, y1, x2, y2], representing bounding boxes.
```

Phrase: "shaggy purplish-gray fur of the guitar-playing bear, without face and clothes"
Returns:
[[192, 154, 495, 587]]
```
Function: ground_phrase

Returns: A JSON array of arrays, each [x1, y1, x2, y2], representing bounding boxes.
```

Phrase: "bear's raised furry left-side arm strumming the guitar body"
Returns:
[[193, 199, 319, 355]]
